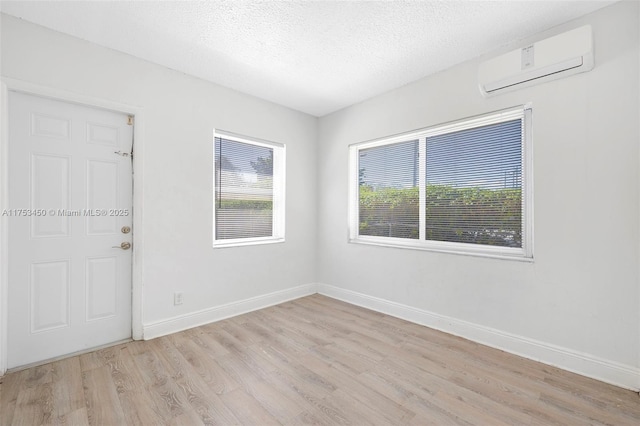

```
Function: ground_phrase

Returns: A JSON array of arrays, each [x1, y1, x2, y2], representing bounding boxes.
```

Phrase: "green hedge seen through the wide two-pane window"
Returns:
[[359, 185, 522, 247]]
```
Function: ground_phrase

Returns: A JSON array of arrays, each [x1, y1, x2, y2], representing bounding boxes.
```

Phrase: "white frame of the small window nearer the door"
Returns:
[[211, 129, 286, 248]]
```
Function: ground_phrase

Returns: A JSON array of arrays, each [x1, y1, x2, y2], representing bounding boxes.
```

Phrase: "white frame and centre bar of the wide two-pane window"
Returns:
[[348, 104, 533, 261]]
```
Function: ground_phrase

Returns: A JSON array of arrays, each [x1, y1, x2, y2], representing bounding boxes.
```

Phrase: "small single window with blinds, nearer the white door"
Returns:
[[213, 131, 285, 247]]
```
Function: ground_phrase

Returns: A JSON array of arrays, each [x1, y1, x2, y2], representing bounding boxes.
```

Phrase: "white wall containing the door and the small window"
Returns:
[[1, 15, 317, 337]]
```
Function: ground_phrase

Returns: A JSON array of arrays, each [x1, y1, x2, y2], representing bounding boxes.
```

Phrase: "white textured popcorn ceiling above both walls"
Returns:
[[0, 0, 614, 116]]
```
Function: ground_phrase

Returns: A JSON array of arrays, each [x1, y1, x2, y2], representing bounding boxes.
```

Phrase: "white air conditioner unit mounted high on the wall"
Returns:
[[478, 25, 593, 96]]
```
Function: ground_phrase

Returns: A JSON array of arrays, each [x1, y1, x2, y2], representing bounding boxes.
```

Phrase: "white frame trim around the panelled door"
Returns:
[[0, 77, 144, 376]]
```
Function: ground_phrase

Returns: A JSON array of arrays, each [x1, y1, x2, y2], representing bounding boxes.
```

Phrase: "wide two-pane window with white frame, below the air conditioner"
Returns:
[[349, 107, 532, 258]]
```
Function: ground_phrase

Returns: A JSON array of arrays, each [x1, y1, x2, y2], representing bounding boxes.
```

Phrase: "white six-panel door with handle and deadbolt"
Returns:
[[2, 92, 133, 368]]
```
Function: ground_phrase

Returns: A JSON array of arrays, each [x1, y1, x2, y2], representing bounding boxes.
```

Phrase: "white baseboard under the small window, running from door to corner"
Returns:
[[142, 284, 317, 340]]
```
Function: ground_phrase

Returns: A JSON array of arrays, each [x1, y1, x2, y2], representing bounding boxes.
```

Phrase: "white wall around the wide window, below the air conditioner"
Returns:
[[318, 2, 640, 388]]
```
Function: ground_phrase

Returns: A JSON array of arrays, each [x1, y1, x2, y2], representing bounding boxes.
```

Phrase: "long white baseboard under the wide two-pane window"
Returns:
[[317, 284, 640, 392]]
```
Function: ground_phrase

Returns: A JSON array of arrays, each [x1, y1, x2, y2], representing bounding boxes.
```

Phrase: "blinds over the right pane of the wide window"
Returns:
[[425, 119, 522, 247]]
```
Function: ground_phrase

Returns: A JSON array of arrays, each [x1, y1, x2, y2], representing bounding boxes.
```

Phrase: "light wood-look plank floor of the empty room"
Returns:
[[0, 295, 640, 426]]
